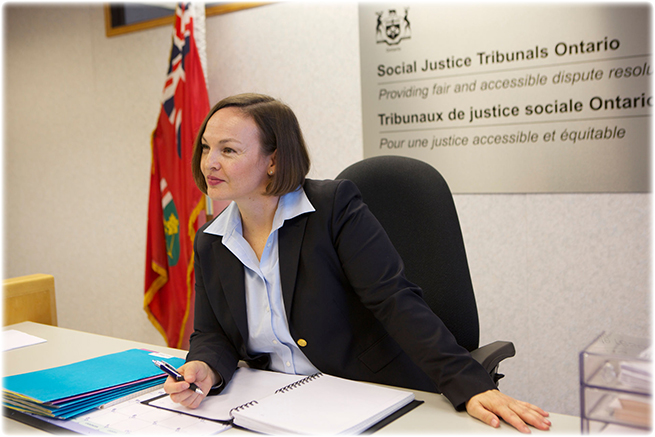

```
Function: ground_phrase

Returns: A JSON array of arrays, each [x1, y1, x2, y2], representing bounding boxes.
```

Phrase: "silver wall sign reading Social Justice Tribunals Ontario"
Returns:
[[359, 2, 655, 193]]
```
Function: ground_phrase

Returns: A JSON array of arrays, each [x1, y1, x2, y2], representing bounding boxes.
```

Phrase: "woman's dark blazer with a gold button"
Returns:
[[187, 180, 496, 409]]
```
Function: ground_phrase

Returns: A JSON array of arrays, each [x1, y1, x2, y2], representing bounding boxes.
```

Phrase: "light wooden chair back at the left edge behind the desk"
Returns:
[[2, 273, 57, 326]]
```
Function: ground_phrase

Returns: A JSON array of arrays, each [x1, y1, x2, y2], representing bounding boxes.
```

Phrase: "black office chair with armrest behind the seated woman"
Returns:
[[337, 156, 516, 385]]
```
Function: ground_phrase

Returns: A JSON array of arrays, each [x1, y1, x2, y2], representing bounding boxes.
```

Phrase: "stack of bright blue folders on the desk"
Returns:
[[3, 349, 184, 419]]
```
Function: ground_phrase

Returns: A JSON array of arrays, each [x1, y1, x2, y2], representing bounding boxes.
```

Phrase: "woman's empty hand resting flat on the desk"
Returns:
[[466, 390, 551, 434]]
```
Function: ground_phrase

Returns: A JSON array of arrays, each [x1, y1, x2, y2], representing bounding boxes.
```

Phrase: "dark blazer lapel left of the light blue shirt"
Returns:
[[212, 239, 248, 344]]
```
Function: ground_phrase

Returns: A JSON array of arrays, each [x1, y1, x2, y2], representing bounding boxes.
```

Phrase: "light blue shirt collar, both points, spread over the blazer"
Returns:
[[204, 186, 316, 237]]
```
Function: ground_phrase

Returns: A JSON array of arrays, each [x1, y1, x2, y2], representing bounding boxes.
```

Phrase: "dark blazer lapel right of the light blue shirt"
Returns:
[[278, 214, 309, 320]]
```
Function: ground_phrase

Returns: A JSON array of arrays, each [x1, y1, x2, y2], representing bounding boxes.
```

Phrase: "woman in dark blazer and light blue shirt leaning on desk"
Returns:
[[165, 94, 550, 432]]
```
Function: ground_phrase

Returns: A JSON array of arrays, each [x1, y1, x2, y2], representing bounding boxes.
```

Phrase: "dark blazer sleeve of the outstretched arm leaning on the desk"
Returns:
[[332, 180, 496, 410]]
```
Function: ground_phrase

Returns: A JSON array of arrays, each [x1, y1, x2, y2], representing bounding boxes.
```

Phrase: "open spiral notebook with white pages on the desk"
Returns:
[[144, 368, 414, 435]]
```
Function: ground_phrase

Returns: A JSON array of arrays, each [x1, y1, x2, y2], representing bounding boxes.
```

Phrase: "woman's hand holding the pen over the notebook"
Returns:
[[164, 361, 220, 408]]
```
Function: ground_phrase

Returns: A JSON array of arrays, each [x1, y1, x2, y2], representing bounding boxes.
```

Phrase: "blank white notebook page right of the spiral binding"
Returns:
[[233, 375, 414, 435]]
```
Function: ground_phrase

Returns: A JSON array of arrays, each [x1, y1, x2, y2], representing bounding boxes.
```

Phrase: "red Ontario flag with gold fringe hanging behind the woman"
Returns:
[[144, 4, 209, 348]]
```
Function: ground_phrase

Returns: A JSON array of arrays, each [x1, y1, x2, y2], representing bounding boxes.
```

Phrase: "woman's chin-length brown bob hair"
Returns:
[[191, 94, 310, 196]]
